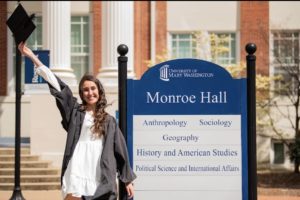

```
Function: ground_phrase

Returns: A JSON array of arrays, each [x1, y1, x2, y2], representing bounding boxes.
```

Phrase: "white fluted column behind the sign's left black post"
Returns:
[[98, 1, 134, 87]]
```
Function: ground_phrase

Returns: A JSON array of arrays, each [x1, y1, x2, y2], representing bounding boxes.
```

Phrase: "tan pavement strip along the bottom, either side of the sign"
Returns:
[[0, 190, 300, 200]]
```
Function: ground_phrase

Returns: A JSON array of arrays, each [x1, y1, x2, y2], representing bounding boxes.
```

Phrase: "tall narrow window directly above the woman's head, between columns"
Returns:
[[71, 16, 89, 82]]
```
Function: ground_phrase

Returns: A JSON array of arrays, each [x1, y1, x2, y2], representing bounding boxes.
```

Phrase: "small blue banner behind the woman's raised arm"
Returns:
[[25, 50, 49, 84]]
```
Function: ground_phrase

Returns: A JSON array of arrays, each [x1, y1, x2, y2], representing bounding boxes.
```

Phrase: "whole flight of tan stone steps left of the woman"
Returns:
[[0, 147, 61, 191]]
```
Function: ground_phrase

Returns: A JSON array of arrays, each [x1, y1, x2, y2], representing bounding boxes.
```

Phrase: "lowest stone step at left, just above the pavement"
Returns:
[[0, 182, 61, 191]]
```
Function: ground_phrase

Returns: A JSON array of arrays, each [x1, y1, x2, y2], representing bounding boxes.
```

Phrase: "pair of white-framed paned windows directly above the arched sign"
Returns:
[[171, 32, 237, 66]]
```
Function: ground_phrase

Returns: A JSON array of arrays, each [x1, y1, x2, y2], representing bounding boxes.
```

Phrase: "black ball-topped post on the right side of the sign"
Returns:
[[246, 43, 257, 200]]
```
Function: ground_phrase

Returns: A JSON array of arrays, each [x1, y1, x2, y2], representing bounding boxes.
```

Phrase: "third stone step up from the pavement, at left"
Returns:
[[0, 167, 60, 176]]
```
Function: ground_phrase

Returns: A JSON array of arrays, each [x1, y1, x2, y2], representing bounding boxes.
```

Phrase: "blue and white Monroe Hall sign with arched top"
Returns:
[[127, 59, 248, 200]]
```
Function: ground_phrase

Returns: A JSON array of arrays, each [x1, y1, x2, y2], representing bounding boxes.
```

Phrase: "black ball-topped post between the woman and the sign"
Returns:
[[117, 44, 128, 200]]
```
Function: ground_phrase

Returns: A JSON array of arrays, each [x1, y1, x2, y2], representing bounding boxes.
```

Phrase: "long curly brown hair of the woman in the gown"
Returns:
[[79, 74, 108, 137]]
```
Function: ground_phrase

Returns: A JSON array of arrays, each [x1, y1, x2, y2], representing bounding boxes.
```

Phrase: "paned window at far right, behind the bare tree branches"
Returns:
[[272, 31, 300, 95]]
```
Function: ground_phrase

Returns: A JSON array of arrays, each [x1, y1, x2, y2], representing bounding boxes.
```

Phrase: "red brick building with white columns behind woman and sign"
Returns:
[[0, 1, 300, 170]]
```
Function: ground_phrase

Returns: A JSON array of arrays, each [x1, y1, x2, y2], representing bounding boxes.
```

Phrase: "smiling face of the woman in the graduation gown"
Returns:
[[82, 81, 99, 106]]
